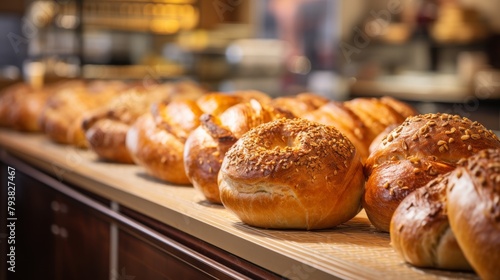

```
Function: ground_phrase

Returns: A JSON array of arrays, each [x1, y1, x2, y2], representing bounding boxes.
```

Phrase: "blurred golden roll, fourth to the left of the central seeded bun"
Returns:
[[40, 80, 130, 148]]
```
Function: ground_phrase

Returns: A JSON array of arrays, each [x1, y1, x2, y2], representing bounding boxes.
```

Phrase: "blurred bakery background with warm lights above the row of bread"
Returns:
[[0, 0, 500, 126]]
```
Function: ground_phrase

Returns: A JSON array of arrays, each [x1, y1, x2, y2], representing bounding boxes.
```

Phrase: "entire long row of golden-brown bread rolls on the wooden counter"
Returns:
[[0, 81, 500, 279]]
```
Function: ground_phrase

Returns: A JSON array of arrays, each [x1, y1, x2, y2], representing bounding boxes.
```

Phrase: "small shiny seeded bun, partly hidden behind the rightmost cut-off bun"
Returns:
[[390, 176, 472, 270]]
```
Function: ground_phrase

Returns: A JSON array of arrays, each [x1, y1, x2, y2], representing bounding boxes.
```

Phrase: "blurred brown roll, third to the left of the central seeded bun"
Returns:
[[82, 83, 203, 163]]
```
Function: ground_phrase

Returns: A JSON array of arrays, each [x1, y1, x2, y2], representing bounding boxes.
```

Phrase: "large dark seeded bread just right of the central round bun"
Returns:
[[363, 114, 500, 231]]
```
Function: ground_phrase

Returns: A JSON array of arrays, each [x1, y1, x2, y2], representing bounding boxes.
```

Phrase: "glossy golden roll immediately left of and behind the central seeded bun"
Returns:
[[184, 99, 294, 203]]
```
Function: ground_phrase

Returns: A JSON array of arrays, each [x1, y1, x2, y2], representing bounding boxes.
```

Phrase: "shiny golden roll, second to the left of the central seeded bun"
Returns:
[[126, 91, 267, 185]]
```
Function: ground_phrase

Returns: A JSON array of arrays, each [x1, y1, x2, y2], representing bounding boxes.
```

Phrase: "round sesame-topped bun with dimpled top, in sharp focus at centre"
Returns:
[[218, 119, 364, 230]]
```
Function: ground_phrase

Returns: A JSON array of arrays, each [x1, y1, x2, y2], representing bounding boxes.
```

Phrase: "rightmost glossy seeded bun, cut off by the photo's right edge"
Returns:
[[447, 149, 500, 280]]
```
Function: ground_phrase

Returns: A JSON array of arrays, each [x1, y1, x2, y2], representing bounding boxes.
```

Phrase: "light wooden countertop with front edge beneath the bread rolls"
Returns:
[[0, 129, 477, 279]]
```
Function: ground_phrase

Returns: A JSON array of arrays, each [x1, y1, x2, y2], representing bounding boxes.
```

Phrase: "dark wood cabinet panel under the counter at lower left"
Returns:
[[2, 161, 110, 280]]
